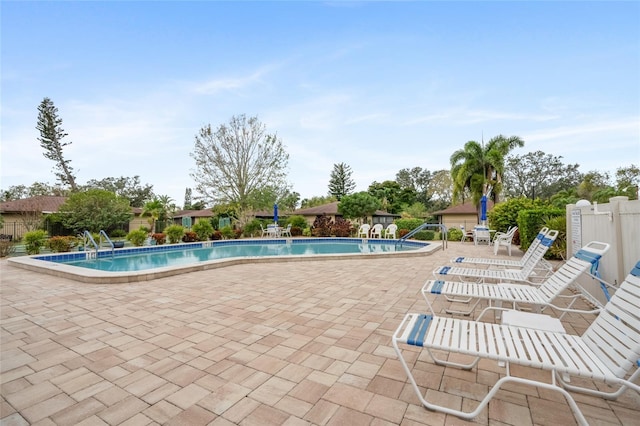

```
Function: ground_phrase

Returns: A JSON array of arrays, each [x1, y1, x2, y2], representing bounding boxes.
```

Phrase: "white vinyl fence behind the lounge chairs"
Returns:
[[567, 197, 640, 303]]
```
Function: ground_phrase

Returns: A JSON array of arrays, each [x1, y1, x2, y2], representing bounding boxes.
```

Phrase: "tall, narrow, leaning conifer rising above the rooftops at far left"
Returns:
[[36, 98, 78, 191]]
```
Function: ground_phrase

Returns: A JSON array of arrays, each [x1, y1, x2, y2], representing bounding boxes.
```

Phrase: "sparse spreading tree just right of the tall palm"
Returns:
[[504, 151, 582, 200]]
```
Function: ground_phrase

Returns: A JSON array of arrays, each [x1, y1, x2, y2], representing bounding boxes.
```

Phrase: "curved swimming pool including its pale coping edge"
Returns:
[[9, 238, 437, 284]]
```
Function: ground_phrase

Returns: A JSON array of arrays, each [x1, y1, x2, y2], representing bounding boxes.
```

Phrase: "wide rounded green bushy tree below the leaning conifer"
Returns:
[[58, 189, 133, 233]]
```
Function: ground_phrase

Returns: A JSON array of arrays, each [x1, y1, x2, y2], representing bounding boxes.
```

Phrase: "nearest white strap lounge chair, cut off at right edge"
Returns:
[[392, 262, 640, 425]]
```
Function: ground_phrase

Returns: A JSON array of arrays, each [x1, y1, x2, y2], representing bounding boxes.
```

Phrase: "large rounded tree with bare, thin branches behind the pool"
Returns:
[[191, 115, 289, 210]]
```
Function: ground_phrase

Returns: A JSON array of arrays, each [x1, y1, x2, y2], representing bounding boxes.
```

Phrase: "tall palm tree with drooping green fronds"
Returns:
[[449, 135, 524, 210]]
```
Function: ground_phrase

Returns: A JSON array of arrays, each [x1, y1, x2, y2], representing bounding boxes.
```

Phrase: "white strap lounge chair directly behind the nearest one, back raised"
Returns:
[[422, 241, 610, 319]]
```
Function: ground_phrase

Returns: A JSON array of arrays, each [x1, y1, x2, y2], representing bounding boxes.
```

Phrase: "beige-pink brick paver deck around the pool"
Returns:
[[0, 242, 640, 426]]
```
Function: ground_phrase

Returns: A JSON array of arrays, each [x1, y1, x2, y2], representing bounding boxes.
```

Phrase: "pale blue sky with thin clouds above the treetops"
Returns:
[[0, 1, 640, 205]]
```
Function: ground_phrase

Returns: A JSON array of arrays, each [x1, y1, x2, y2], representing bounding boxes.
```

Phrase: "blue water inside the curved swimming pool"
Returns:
[[37, 238, 426, 272]]
